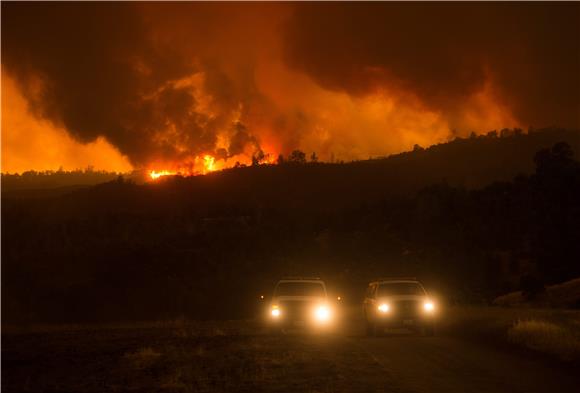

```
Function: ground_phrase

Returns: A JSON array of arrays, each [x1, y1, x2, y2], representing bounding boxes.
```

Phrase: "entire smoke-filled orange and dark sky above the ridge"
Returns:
[[2, 2, 580, 172]]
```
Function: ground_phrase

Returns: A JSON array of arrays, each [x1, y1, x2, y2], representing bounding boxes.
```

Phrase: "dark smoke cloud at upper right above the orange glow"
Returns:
[[285, 3, 580, 126]]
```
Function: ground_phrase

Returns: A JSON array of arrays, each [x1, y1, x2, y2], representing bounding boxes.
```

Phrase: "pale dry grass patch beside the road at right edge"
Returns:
[[508, 319, 580, 360]]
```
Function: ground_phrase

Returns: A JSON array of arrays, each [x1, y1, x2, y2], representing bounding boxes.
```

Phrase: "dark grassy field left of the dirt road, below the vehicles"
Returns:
[[2, 322, 398, 392]]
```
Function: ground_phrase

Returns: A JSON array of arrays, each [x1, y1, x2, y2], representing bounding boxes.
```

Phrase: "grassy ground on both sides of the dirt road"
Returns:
[[2, 308, 580, 393]]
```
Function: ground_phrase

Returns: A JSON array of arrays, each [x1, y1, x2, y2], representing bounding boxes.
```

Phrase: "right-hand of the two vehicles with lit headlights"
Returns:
[[363, 278, 436, 336]]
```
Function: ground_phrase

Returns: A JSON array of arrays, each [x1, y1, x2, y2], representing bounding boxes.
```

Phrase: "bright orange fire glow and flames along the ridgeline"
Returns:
[[2, 61, 517, 176]]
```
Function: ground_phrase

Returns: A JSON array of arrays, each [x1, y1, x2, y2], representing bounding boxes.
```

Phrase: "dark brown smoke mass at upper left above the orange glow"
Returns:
[[2, 3, 188, 161]]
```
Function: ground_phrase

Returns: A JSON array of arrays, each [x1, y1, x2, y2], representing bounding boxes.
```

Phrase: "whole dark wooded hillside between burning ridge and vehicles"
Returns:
[[2, 127, 580, 322]]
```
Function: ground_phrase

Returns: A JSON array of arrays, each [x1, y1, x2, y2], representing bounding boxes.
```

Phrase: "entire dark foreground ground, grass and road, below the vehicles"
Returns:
[[2, 310, 580, 393]]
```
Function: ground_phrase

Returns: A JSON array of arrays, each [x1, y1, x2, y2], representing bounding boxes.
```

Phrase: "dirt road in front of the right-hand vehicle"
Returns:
[[349, 335, 580, 393]]
